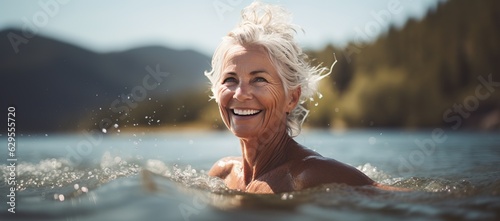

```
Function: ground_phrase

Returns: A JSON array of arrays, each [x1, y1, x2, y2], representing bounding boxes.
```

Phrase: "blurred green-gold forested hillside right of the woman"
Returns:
[[309, 0, 500, 129]]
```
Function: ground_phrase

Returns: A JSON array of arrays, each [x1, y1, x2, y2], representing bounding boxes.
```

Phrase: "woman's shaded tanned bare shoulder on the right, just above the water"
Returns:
[[291, 155, 375, 189]]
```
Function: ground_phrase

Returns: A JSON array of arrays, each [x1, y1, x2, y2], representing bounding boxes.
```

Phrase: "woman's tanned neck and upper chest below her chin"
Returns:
[[240, 131, 295, 185]]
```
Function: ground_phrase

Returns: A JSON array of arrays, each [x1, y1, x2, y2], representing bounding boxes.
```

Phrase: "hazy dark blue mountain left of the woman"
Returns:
[[0, 29, 210, 132]]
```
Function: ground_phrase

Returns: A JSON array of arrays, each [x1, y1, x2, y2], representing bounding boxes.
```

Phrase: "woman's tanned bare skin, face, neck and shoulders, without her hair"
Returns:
[[208, 45, 402, 193]]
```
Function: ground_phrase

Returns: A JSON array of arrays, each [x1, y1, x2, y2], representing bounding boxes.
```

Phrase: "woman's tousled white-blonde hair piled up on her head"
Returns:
[[205, 2, 329, 137]]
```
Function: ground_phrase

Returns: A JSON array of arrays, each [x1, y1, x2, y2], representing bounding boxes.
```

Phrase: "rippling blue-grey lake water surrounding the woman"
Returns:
[[0, 130, 500, 221]]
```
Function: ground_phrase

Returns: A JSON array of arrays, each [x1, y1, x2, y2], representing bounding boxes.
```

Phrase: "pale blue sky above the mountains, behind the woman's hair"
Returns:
[[0, 0, 439, 56]]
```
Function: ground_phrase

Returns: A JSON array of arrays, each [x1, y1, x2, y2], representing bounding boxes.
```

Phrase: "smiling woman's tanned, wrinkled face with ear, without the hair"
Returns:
[[216, 45, 300, 138]]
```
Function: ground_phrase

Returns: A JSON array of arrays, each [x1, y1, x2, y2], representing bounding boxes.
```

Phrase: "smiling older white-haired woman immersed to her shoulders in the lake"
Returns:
[[206, 3, 396, 193]]
